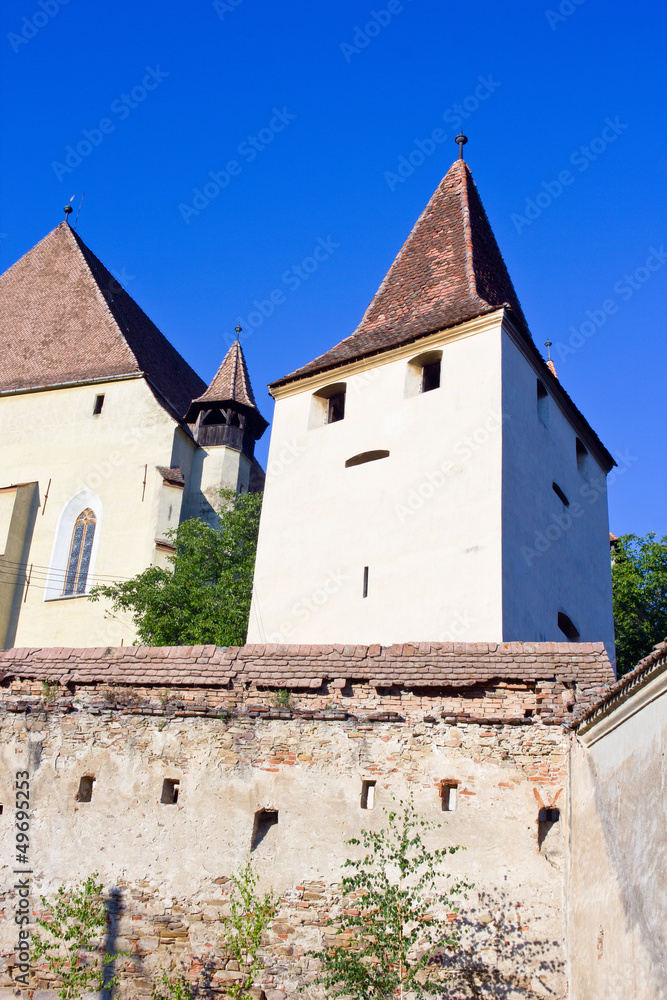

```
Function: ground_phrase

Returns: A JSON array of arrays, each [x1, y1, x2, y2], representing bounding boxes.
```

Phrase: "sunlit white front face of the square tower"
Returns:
[[249, 311, 502, 644]]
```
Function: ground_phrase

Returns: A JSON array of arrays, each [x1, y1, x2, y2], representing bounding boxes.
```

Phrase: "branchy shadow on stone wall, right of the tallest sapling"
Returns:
[[433, 887, 567, 1000]]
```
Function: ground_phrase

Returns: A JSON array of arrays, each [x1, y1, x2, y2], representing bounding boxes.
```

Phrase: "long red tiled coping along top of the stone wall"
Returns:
[[0, 642, 614, 721]]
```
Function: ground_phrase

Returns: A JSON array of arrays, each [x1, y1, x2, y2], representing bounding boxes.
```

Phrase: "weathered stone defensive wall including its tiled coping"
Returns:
[[0, 643, 614, 1000]]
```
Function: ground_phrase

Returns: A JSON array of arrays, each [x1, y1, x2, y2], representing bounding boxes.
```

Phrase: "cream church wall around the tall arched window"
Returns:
[[0, 379, 194, 646]]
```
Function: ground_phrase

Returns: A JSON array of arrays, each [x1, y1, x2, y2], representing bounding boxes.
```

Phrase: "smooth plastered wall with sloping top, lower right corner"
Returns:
[[566, 650, 667, 1000]]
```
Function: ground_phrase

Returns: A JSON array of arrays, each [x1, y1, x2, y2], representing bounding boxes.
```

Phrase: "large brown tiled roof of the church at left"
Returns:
[[0, 222, 204, 416]]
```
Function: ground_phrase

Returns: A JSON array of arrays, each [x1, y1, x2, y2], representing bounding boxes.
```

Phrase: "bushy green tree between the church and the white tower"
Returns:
[[90, 490, 262, 646]]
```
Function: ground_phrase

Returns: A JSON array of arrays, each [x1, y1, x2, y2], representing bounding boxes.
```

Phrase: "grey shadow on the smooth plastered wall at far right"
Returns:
[[588, 752, 667, 998]]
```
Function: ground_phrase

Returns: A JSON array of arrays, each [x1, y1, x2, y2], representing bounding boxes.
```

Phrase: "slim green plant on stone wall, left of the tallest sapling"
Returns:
[[220, 860, 276, 1000]]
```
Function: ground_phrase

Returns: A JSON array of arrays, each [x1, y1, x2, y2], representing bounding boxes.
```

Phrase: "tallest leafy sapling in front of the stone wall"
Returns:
[[318, 796, 473, 1000]]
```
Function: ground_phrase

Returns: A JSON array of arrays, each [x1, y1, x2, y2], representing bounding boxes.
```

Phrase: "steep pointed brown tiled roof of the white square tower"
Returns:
[[273, 160, 530, 386]]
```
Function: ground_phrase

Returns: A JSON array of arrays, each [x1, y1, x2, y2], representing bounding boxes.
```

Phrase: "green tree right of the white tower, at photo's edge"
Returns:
[[611, 531, 667, 677]]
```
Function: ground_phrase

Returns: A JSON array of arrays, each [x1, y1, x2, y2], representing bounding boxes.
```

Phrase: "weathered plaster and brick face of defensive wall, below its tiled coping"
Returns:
[[0, 660, 568, 1000]]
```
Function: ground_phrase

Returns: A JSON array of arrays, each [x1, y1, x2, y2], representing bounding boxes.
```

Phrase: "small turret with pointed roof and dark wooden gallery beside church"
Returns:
[[185, 336, 268, 525]]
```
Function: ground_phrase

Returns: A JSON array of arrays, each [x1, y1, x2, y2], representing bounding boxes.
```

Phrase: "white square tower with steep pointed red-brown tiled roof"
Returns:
[[248, 145, 614, 655]]
